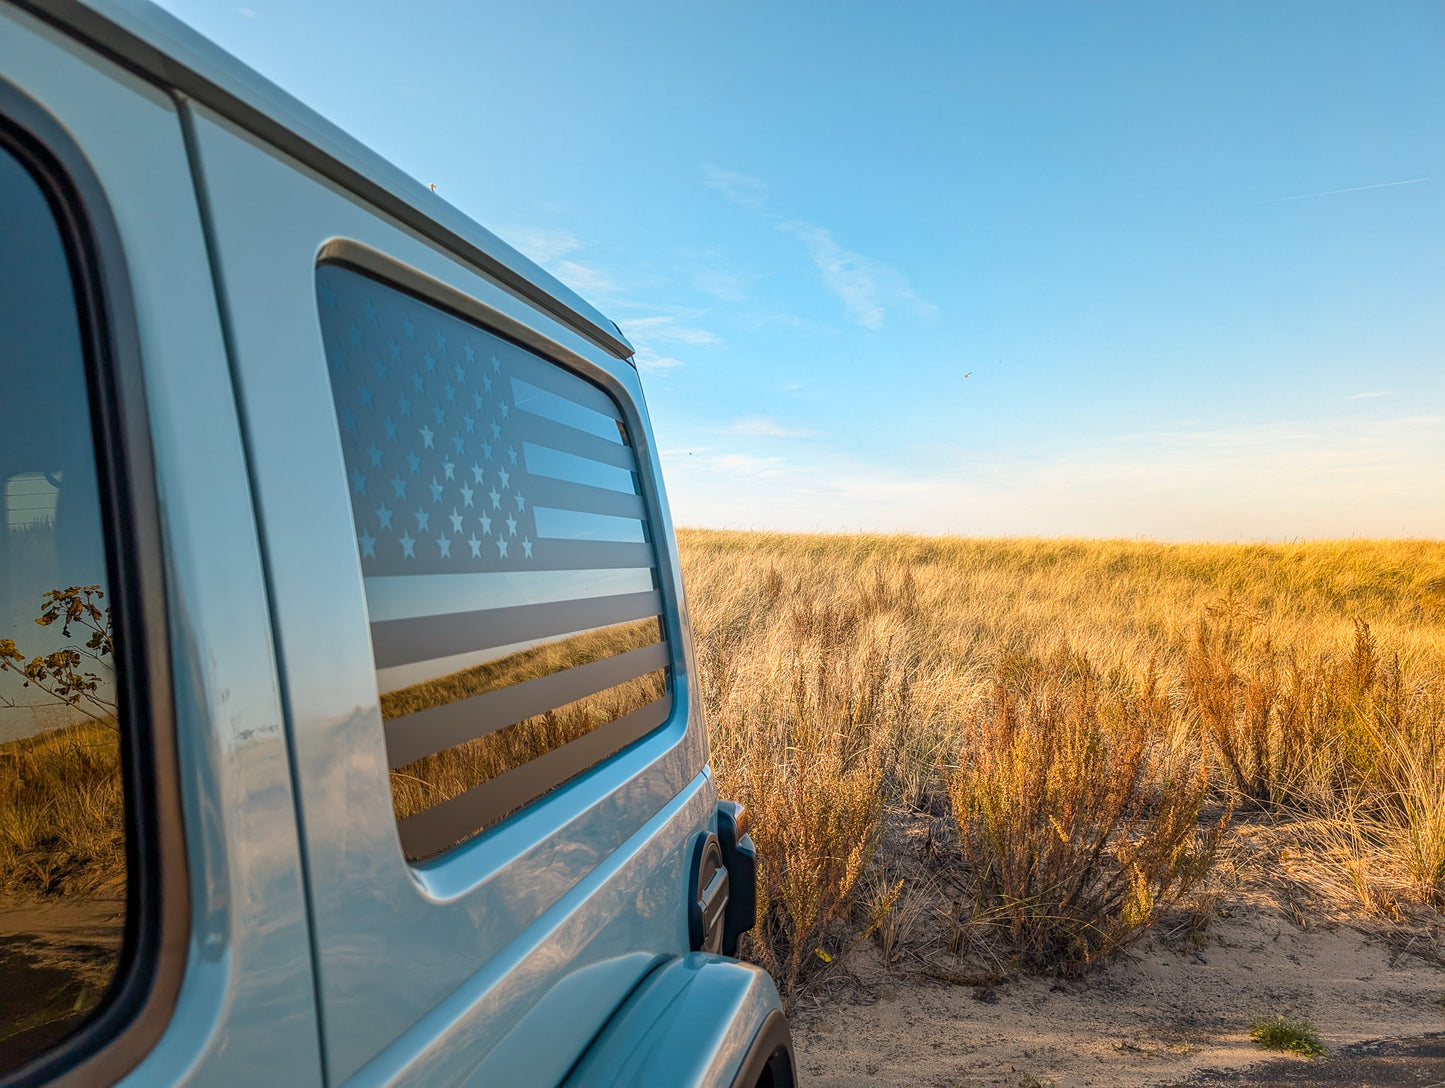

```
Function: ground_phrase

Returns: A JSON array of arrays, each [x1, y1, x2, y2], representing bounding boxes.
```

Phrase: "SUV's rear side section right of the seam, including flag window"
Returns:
[[191, 105, 715, 1085]]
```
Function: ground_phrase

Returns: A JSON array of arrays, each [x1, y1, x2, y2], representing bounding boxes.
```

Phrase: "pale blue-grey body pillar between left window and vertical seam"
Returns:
[[0, 9, 321, 1085]]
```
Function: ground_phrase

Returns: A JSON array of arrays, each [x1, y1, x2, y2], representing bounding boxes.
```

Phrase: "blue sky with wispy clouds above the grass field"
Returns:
[[152, 0, 1445, 540]]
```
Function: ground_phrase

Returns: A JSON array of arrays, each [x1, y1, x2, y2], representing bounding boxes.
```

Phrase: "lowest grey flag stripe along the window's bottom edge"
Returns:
[[397, 692, 672, 860]]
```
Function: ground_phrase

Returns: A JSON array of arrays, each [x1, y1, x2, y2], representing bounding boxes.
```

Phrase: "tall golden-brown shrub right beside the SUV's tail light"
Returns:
[[699, 578, 910, 998]]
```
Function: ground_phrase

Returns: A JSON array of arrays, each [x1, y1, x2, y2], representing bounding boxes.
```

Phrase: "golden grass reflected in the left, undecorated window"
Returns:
[[0, 722, 126, 896]]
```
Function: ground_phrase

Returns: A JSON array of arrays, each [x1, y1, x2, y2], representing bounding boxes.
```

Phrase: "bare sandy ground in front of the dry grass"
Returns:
[[793, 813, 1445, 1088]]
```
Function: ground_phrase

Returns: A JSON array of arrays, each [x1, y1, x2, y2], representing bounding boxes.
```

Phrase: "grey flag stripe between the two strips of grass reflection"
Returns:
[[386, 642, 669, 770]]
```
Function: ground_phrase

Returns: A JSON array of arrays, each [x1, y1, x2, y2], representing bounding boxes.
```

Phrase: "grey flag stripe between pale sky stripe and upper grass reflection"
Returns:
[[371, 589, 662, 669]]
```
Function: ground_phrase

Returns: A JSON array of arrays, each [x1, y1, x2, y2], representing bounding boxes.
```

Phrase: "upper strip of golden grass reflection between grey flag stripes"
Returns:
[[381, 620, 660, 718]]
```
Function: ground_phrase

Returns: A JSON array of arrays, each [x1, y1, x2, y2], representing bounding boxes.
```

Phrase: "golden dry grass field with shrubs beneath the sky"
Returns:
[[679, 530, 1445, 1007]]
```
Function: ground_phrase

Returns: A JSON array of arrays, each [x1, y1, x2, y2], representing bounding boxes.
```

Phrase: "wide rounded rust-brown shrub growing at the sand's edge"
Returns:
[[949, 653, 1224, 974]]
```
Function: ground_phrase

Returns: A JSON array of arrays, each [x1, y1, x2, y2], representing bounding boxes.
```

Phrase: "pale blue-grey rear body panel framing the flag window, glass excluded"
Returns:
[[192, 107, 715, 1084]]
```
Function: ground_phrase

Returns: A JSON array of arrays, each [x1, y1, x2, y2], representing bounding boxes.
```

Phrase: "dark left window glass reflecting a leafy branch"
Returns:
[[0, 135, 127, 1075]]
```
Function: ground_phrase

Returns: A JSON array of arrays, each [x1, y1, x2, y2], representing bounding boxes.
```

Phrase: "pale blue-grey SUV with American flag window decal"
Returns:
[[0, 0, 793, 1088]]
